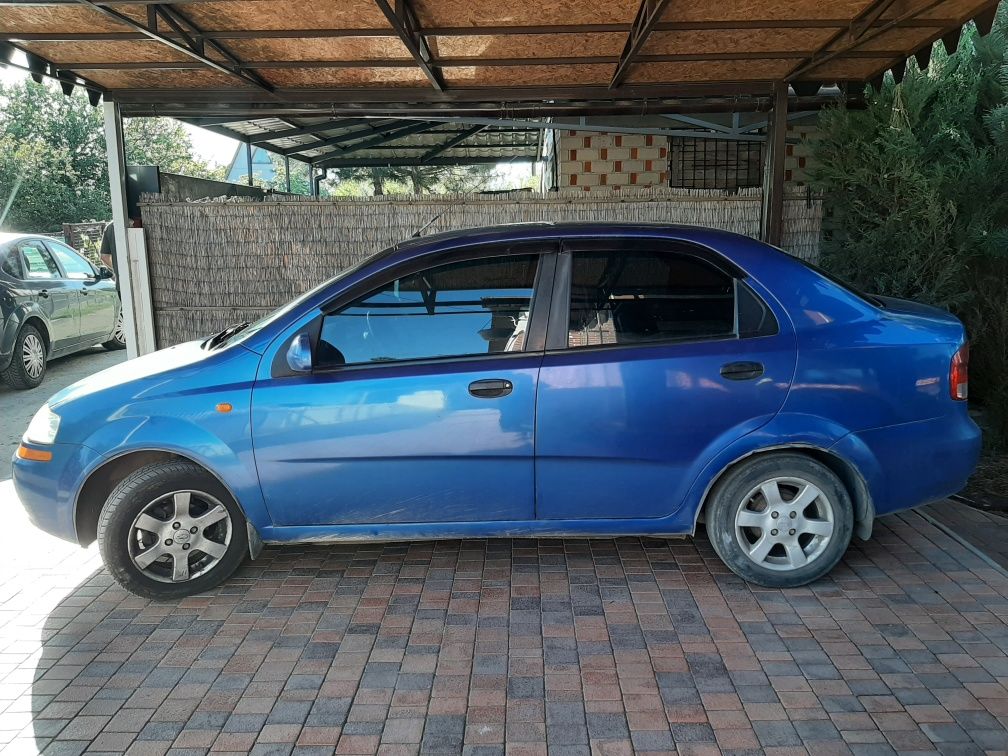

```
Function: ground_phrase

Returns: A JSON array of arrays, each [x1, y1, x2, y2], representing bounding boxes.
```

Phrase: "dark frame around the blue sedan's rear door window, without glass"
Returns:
[[546, 237, 780, 354]]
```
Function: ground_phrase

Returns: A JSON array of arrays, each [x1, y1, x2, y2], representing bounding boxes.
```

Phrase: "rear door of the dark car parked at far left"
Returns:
[[17, 239, 81, 353]]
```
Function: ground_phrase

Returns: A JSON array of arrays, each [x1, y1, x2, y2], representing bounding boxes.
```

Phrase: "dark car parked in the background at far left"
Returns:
[[0, 234, 126, 389]]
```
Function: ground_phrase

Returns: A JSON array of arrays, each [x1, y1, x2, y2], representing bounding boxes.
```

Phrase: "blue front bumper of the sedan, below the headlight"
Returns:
[[12, 444, 98, 543]]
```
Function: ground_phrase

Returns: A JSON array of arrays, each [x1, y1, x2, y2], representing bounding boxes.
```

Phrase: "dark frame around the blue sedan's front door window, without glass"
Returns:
[[270, 241, 558, 378]]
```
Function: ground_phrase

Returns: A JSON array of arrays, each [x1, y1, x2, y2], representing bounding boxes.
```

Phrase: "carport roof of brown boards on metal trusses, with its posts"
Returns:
[[0, 0, 997, 358]]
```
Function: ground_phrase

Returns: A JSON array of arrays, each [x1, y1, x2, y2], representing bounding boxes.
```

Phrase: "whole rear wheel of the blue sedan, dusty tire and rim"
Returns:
[[706, 454, 854, 588]]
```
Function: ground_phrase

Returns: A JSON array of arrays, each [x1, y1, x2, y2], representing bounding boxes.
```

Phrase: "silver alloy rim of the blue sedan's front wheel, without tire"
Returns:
[[127, 491, 232, 583]]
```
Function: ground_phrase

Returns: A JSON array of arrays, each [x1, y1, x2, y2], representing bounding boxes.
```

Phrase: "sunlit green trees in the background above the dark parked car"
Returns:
[[0, 79, 221, 232]]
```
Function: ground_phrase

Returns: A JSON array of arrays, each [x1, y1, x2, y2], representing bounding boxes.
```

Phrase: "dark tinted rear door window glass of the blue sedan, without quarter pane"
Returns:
[[568, 252, 736, 348]]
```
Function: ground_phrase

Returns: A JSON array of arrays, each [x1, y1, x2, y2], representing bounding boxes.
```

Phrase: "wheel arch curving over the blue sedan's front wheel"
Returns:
[[74, 449, 262, 558]]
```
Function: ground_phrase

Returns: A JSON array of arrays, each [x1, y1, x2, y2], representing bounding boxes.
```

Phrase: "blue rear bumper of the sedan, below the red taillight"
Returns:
[[834, 405, 981, 515]]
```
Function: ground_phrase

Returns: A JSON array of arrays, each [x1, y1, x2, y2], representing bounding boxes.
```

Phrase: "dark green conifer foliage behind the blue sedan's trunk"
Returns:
[[812, 8, 1008, 443]]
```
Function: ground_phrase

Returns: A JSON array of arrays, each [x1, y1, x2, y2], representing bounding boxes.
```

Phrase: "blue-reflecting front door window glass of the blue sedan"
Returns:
[[316, 255, 538, 367]]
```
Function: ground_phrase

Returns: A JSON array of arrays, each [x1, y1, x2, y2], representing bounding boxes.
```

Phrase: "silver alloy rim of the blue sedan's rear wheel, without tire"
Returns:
[[735, 478, 836, 572]]
